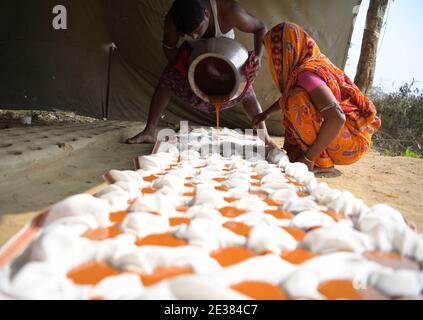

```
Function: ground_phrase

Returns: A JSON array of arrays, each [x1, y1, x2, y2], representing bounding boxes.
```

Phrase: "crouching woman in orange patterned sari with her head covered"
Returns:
[[253, 23, 381, 172]]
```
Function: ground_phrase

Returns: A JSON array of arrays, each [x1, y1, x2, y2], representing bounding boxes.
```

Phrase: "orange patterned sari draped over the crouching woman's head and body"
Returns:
[[265, 23, 381, 168]]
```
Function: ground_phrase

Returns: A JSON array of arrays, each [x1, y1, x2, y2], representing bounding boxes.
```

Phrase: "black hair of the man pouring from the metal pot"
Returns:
[[171, 0, 204, 34]]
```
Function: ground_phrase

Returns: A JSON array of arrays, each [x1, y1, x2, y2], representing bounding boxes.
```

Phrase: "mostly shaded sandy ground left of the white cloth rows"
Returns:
[[0, 122, 153, 246]]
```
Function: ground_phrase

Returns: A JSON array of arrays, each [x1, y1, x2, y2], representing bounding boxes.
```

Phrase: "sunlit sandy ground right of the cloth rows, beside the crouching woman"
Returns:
[[276, 138, 423, 232]]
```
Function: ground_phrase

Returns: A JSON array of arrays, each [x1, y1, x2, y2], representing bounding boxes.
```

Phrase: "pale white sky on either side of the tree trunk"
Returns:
[[345, 0, 423, 92]]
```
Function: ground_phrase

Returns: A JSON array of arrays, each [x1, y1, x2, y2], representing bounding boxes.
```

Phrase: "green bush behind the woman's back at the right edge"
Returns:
[[369, 84, 423, 158]]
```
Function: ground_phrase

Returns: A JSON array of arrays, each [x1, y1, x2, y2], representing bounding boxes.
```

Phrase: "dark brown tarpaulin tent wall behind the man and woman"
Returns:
[[0, 0, 361, 133]]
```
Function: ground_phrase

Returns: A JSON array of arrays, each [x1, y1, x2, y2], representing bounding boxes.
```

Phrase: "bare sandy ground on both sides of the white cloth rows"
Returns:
[[0, 129, 423, 245]]
